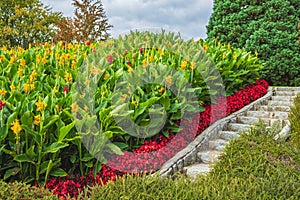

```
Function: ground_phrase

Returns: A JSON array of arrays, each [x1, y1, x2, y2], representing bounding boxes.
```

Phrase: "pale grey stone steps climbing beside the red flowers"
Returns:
[[183, 87, 300, 177]]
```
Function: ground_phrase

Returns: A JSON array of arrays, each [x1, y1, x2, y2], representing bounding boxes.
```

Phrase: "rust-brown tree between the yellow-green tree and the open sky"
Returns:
[[55, 0, 112, 43]]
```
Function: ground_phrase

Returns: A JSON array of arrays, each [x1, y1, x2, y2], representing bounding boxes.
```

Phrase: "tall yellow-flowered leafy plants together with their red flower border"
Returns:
[[0, 32, 268, 196]]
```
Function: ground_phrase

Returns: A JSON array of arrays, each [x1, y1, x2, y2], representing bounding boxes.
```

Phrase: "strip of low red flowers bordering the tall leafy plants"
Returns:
[[46, 80, 268, 197]]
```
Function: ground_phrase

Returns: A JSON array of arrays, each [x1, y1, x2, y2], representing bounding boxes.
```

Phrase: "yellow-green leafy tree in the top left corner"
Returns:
[[0, 0, 61, 48]]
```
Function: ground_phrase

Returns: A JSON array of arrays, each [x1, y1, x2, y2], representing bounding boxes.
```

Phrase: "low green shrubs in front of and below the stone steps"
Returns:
[[89, 123, 300, 199]]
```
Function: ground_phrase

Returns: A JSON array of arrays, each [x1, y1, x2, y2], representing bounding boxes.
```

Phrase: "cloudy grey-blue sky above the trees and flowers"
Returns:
[[41, 0, 213, 39]]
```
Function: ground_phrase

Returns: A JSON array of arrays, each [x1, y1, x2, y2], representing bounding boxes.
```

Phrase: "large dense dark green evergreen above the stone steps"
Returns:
[[207, 0, 300, 86]]
